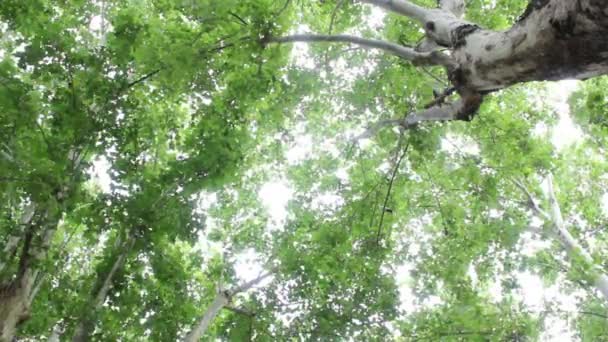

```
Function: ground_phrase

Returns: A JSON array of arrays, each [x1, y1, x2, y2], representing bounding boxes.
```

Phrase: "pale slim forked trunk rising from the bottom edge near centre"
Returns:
[[184, 272, 272, 342]]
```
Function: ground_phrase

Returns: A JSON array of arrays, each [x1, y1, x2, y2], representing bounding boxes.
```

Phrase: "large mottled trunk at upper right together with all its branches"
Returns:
[[276, 0, 608, 131]]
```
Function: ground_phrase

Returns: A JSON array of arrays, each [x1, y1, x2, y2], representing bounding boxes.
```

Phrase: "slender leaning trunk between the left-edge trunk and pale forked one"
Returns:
[[72, 236, 135, 342]]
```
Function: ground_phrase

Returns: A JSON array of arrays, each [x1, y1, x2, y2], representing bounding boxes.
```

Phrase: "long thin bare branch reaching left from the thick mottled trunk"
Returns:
[[268, 34, 455, 67]]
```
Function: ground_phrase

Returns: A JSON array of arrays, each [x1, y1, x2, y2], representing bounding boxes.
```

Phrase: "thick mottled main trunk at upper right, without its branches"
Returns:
[[454, 0, 608, 91]]
